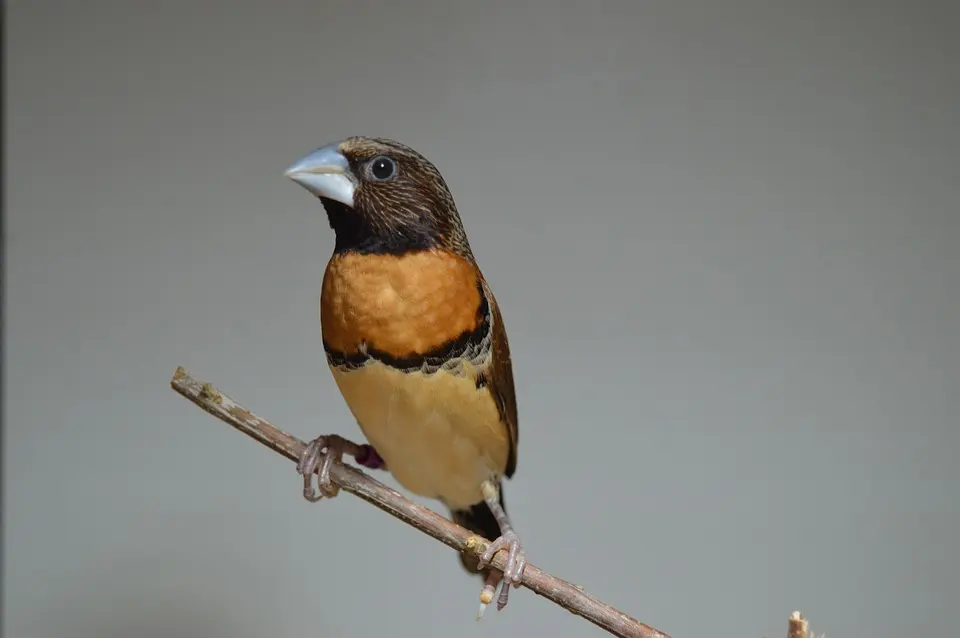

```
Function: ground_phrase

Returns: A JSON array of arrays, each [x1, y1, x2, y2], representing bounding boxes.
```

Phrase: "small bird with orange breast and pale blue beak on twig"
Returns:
[[284, 136, 527, 619]]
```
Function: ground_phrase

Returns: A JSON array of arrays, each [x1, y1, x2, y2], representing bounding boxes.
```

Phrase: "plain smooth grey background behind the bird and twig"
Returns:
[[3, 0, 960, 638]]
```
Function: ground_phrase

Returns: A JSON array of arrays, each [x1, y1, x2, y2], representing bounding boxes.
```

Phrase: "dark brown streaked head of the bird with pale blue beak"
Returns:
[[284, 137, 470, 255]]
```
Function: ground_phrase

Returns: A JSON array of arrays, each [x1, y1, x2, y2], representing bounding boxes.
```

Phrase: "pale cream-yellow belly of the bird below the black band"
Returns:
[[331, 362, 509, 509]]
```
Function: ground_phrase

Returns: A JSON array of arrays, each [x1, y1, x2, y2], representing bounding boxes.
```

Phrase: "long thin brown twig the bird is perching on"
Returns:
[[170, 368, 670, 638]]
